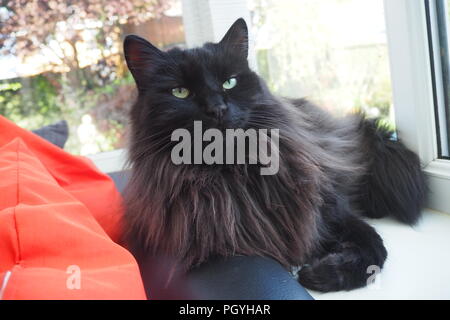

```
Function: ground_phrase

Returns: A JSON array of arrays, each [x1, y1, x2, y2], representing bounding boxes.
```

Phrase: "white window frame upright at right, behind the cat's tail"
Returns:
[[384, 0, 450, 213]]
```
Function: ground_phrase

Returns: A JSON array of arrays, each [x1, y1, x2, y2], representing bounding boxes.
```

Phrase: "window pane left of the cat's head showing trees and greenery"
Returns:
[[0, 0, 185, 154]]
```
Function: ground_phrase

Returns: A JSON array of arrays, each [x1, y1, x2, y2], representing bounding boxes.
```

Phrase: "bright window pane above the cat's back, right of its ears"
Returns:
[[251, 0, 394, 125]]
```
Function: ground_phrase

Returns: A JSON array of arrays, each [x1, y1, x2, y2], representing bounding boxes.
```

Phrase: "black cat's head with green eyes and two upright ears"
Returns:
[[124, 19, 266, 136]]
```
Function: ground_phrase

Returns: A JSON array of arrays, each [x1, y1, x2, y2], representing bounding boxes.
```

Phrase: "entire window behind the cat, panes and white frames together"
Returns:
[[0, 0, 450, 212]]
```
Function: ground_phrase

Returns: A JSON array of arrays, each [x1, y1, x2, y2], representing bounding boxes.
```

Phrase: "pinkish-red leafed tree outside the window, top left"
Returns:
[[0, 0, 171, 77]]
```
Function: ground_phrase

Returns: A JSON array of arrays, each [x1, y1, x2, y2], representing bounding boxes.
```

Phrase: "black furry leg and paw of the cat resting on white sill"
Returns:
[[298, 194, 387, 292]]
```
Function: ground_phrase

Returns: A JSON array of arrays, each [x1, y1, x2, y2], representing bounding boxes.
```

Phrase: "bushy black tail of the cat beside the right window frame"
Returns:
[[357, 119, 427, 225]]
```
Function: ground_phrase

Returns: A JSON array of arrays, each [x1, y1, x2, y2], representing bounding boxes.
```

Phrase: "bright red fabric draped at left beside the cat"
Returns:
[[0, 116, 146, 299]]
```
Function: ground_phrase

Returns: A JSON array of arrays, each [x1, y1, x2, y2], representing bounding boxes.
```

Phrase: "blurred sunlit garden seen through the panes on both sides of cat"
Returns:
[[0, 0, 394, 154]]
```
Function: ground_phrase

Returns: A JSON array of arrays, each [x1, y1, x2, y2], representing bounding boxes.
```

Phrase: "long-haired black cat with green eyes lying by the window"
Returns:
[[124, 19, 426, 291]]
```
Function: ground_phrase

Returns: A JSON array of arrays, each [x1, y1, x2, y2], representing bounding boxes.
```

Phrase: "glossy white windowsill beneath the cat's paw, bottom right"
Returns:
[[310, 209, 450, 300]]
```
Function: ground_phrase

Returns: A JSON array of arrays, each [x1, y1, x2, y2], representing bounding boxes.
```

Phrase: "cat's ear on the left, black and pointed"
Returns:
[[123, 35, 164, 90]]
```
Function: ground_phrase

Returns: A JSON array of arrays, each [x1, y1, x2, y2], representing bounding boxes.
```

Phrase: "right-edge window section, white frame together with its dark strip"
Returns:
[[384, 0, 450, 213]]
